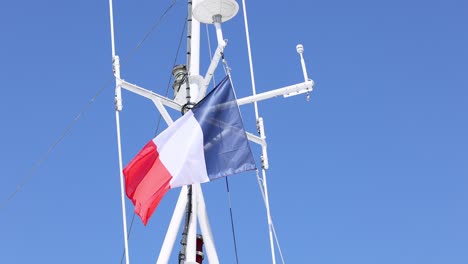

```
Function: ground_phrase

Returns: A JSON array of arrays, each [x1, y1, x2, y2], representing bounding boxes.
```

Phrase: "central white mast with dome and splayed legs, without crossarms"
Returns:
[[163, 0, 239, 264]]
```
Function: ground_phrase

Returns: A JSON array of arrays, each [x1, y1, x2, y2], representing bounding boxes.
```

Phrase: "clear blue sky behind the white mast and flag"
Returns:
[[0, 0, 468, 264]]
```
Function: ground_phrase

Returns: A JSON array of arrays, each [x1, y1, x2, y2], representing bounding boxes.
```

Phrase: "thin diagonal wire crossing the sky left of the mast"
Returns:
[[0, 0, 177, 209]]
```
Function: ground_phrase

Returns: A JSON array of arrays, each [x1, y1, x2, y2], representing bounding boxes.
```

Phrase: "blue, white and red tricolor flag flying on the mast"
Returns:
[[123, 76, 256, 225]]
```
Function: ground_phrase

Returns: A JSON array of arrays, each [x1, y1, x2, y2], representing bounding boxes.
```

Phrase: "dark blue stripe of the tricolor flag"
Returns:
[[192, 76, 256, 180]]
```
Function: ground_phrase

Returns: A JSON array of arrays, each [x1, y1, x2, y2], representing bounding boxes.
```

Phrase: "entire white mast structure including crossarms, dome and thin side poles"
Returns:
[[109, 0, 314, 264]]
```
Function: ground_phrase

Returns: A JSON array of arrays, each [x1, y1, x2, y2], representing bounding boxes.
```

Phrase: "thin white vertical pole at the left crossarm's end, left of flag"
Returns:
[[109, 0, 130, 264]]
